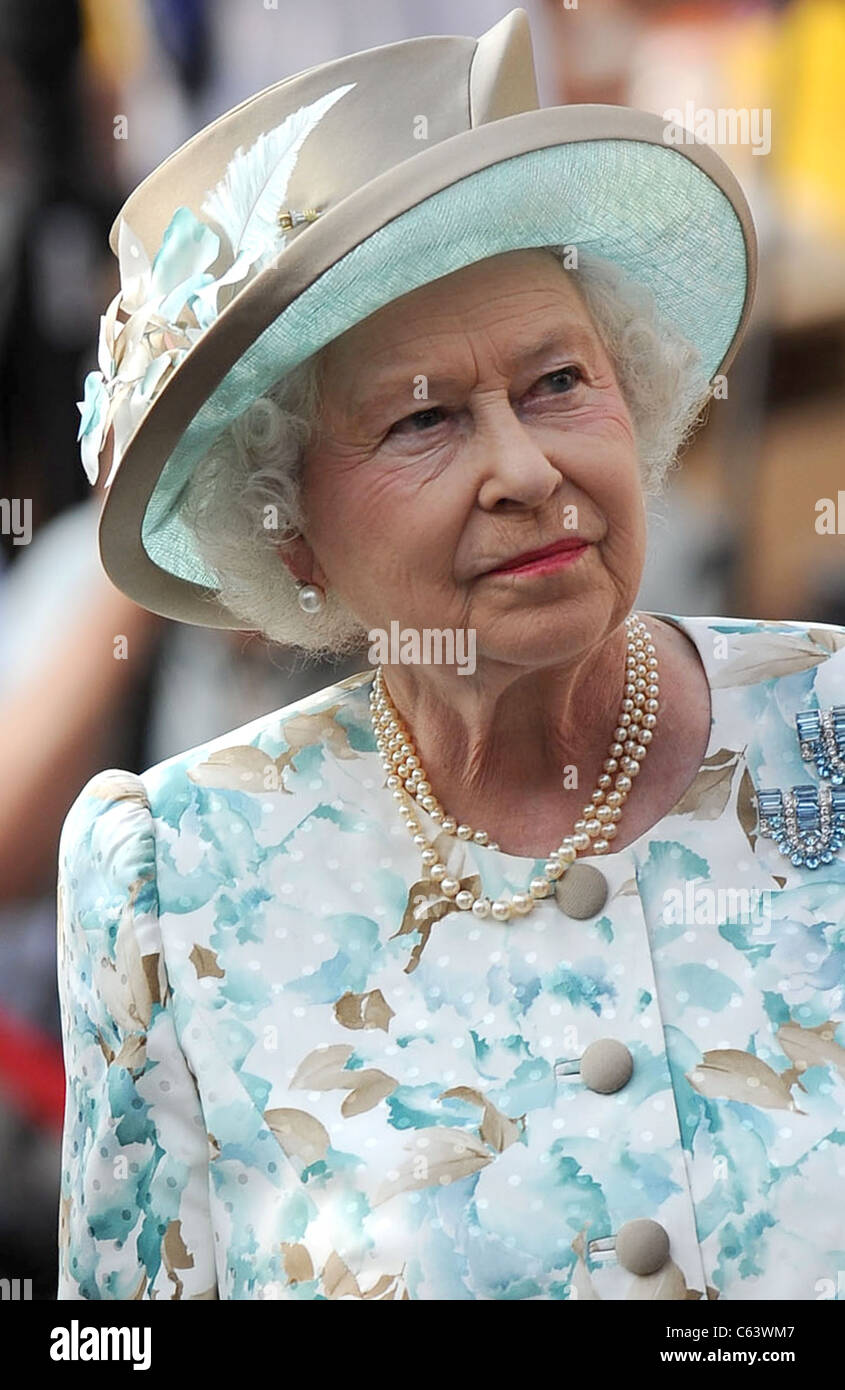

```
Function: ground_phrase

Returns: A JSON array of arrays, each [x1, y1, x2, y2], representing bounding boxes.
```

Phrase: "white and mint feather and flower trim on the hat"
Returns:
[[76, 82, 354, 487]]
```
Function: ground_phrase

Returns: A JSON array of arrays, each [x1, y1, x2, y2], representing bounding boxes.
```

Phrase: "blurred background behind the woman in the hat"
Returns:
[[0, 0, 845, 1298]]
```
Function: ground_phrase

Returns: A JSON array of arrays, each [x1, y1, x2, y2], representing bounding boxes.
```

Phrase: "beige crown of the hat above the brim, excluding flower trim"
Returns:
[[110, 10, 538, 259]]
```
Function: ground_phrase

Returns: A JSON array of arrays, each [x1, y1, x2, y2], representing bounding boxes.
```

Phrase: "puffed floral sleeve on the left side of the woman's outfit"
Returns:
[[57, 769, 218, 1298]]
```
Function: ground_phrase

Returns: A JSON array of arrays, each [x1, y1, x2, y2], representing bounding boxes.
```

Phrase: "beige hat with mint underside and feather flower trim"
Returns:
[[79, 10, 756, 628]]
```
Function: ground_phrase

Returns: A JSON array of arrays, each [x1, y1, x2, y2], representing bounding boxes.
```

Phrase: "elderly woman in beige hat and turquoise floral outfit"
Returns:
[[58, 11, 845, 1300]]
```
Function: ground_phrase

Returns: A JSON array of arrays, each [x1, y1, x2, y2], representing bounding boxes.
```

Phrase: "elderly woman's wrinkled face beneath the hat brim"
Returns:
[[296, 250, 645, 667]]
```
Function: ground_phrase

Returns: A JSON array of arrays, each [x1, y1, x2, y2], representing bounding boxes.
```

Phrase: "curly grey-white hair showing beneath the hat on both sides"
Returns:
[[179, 246, 710, 662]]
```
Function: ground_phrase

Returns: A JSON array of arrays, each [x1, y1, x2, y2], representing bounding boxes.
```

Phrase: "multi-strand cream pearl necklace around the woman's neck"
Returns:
[[370, 613, 660, 922]]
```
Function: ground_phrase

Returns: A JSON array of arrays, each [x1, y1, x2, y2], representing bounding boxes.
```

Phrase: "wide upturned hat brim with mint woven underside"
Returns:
[[99, 106, 756, 628]]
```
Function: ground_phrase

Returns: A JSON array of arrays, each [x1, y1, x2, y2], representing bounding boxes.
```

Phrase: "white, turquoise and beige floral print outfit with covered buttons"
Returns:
[[58, 614, 845, 1300]]
